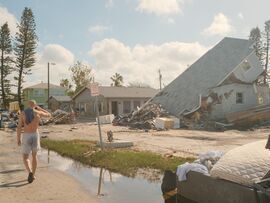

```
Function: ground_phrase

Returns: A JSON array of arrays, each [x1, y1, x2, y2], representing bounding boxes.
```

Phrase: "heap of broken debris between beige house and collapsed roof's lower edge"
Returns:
[[113, 102, 169, 129]]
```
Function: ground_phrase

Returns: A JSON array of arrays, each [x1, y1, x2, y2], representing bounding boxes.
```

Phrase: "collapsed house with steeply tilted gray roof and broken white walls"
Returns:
[[149, 37, 269, 128]]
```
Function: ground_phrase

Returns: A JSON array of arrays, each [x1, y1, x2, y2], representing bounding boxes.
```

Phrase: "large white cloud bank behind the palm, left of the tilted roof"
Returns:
[[89, 39, 207, 88]]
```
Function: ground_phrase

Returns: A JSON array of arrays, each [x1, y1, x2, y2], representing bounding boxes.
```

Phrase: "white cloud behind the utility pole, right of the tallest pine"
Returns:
[[25, 44, 74, 86]]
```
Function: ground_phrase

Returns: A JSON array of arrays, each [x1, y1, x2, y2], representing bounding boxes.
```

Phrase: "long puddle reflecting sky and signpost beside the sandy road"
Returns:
[[39, 149, 164, 203]]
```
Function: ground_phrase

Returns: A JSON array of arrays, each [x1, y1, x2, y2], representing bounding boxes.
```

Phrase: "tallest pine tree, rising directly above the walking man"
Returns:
[[14, 7, 37, 105]]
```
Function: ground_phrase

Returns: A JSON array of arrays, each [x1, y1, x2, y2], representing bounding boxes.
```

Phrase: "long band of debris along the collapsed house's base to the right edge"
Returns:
[[113, 102, 270, 131]]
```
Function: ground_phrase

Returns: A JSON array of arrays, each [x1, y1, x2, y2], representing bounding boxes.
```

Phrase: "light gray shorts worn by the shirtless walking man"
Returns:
[[22, 132, 40, 154]]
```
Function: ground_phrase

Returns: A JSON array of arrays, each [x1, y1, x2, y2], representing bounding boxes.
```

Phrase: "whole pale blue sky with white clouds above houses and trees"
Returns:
[[0, 0, 270, 87]]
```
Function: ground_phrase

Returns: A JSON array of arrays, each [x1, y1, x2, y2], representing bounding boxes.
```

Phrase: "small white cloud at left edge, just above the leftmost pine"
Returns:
[[0, 7, 18, 35]]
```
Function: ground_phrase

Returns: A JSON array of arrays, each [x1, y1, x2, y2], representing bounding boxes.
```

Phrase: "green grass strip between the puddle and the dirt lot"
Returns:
[[41, 139, 194, 176]]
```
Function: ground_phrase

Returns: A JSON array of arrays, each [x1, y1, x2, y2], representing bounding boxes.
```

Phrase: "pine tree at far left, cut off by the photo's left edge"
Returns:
[[0, 23, 12, 108]]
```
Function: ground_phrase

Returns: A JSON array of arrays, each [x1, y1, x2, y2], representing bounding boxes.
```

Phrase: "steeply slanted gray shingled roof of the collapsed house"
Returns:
[[152, 38, 258, 116]]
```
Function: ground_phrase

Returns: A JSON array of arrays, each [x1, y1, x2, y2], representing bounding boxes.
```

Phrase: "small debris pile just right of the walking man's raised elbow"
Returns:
[[44, 109, 74, 125]]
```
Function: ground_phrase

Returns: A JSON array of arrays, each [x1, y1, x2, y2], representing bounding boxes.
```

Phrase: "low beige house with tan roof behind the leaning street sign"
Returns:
[[73, 86, 158, 117]]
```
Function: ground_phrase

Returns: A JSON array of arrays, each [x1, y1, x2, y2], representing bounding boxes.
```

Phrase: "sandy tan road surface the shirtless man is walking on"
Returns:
[[0, 131, 98, 203]]
